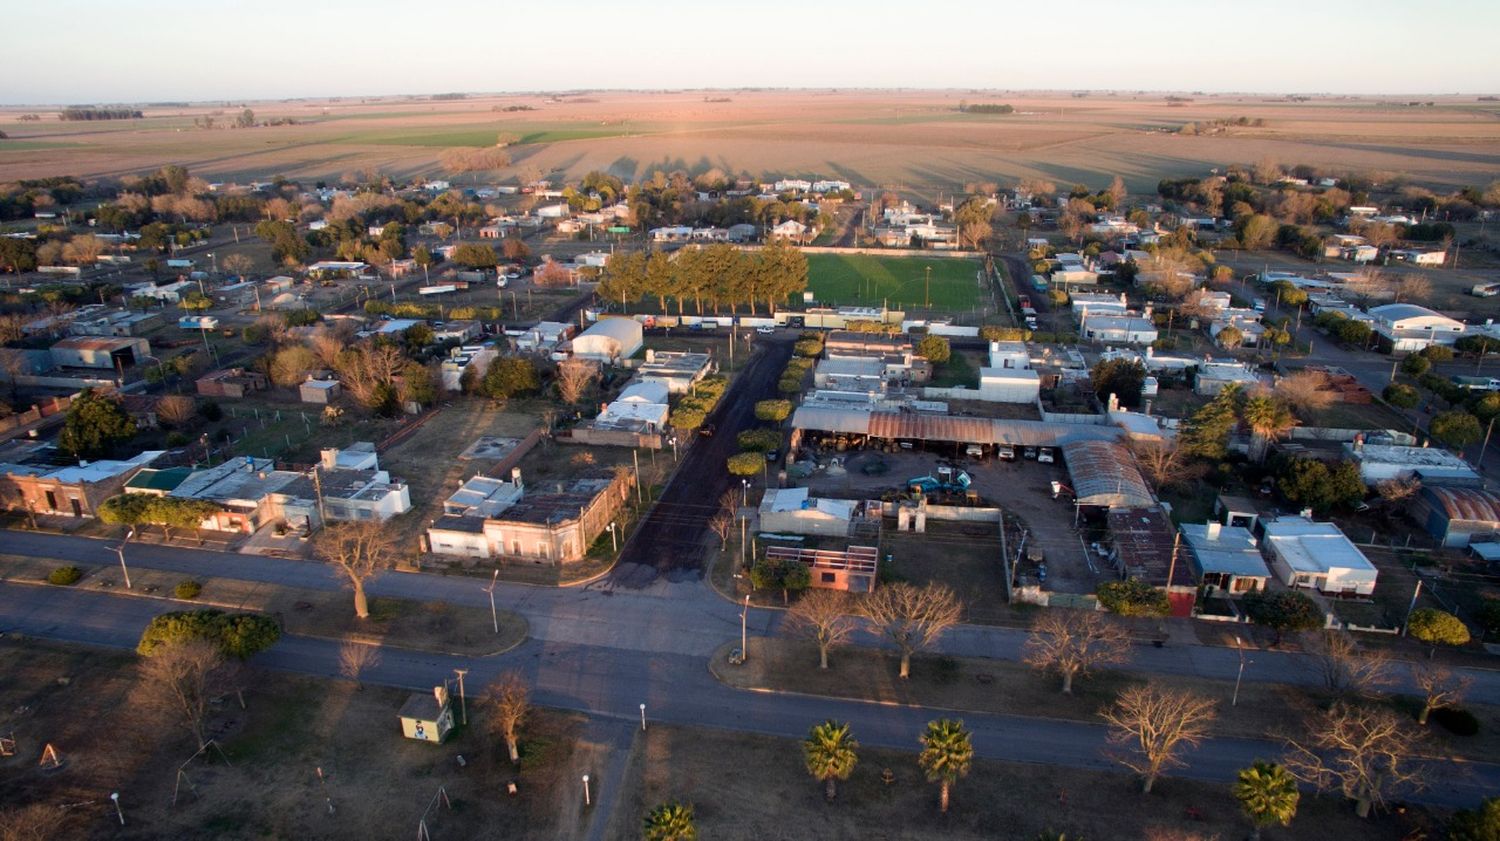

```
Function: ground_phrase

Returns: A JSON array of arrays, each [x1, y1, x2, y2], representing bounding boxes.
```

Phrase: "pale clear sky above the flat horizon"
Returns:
[[0, 0, 1500, 105]]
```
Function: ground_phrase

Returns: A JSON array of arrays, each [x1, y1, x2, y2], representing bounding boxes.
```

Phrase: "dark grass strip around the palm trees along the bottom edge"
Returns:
[[606, 721, 1436, 841]]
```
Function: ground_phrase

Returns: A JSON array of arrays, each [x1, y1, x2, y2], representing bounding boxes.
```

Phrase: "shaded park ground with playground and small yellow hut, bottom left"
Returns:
[[0, 640, 603, 841]]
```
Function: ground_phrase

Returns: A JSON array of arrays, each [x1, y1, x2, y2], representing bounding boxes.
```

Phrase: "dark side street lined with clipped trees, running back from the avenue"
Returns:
[[608, 331, 795, 589]]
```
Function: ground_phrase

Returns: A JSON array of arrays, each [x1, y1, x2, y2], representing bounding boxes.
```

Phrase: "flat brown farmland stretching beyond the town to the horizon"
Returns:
[[0, 90, 1500, 193]]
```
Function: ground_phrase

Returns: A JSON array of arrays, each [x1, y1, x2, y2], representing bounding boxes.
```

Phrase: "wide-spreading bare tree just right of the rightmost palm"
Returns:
[[1286, 702, 1424, 817]]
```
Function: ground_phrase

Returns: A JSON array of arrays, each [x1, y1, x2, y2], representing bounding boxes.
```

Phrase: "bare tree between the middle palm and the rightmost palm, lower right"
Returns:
[[1100, 684, 1218, 793]]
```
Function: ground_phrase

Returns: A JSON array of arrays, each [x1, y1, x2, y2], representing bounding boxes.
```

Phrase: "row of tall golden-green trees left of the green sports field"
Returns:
[[599, 241, 807, 315]]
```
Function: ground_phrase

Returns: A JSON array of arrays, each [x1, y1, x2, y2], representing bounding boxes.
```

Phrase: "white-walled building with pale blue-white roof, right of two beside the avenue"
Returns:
[[1260, 517, 1377, 595]]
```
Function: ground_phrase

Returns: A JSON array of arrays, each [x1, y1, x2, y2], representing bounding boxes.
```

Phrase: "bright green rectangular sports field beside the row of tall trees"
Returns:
[[807, 253, 980, 310]]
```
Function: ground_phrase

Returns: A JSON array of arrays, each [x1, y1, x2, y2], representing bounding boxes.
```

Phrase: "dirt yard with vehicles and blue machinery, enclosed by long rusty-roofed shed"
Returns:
[[789, 447, 1112, 598]]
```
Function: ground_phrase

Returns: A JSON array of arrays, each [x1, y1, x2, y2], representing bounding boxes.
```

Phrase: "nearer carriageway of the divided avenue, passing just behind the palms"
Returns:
[[0, 575, 1500, 807]]
